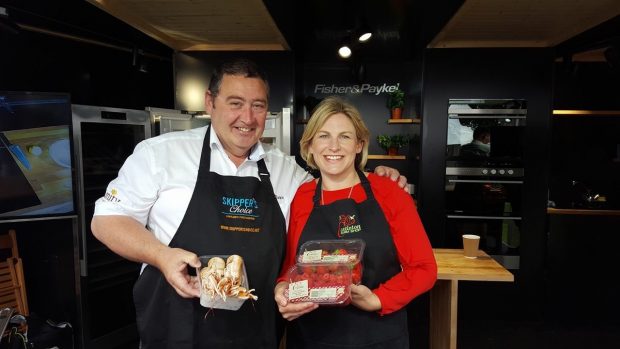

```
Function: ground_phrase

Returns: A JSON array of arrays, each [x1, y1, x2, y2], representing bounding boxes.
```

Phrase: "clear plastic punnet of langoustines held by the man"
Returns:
[[196, 255, 258, 310]]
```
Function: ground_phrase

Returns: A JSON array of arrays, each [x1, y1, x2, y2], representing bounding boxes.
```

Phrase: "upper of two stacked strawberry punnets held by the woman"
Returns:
[[297, 239, 366, 264]]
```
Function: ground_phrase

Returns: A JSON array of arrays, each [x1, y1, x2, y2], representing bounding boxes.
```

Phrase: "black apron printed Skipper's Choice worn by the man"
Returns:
[[134, 128, 286, 349]]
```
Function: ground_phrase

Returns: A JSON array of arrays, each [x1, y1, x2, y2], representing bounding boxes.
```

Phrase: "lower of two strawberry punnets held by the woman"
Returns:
[[284, 263, 351, 306]]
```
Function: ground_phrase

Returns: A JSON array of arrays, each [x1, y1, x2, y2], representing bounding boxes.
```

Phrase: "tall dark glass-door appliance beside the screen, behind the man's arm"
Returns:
[[71, 104, 151, 349]]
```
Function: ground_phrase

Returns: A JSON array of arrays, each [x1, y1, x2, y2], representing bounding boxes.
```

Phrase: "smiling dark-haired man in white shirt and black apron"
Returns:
[[92, 60, 404, 349]]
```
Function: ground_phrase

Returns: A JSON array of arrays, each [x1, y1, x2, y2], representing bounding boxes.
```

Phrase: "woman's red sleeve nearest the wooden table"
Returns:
[[368, 174, 437, 315]]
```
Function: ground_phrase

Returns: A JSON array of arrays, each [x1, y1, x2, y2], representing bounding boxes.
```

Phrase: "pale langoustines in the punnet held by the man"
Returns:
[[200, 255, 258, 301]]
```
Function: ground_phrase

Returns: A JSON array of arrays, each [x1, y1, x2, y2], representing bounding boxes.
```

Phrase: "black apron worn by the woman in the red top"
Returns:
[[287, 171, 409, 349]]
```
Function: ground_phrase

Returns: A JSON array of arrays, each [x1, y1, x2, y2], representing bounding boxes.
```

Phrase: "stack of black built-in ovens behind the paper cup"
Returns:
[[445, 99, 527, 269]]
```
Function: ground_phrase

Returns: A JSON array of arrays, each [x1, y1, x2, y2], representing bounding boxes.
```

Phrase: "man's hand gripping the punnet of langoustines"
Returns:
[[157, 247, 200, 298]]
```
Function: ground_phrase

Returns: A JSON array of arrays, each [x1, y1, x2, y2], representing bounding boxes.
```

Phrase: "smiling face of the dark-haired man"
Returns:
[[206, 75, 268, 160]]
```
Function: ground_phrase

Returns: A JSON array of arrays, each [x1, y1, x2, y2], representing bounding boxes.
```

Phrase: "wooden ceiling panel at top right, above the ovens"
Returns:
[[428, 0, 620, 48]]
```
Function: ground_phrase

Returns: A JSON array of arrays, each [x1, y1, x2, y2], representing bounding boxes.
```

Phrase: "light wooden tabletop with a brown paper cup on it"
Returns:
[[433, 248, 514, 282]]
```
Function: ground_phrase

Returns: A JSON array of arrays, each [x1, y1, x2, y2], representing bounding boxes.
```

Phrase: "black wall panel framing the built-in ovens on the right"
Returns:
[[418, 48, 553, 316]]
